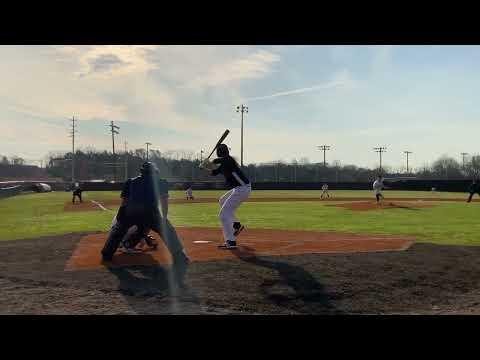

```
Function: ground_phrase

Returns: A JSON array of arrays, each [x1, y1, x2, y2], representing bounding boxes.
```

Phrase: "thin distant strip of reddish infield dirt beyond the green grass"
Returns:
[[64, 197, 472, 211]]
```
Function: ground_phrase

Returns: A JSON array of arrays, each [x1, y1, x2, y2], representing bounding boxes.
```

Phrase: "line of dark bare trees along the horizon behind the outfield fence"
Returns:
[[36, 149, 480, 182]]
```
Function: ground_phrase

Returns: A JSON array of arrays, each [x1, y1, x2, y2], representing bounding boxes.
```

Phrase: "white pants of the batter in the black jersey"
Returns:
[[218, 184, 252, 242]]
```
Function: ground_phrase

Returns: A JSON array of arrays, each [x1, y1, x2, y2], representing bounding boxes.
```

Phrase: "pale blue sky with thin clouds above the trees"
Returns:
[[0, 45, 480, 169]]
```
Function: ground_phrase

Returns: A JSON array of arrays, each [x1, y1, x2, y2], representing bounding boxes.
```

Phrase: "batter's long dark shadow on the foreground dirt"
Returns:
[[232, 246, 342, 315]]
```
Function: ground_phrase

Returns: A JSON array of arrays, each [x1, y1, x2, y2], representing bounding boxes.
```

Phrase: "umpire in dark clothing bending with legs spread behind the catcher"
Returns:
[[102, 162, 190, 277]]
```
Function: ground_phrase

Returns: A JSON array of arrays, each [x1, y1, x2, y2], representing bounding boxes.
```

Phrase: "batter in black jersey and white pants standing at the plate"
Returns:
[[202, 144, 252, 250]]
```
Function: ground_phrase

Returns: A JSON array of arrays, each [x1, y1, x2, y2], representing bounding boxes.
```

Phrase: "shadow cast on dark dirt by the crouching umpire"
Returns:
[[108, 252, 201, 314]]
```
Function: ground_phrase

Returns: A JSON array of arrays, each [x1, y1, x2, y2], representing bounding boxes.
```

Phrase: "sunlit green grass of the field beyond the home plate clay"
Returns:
[[0, 191, 480, 245]]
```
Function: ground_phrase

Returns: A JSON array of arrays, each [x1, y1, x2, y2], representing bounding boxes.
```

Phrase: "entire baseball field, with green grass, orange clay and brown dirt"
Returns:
[[0, 190, 480, 314]]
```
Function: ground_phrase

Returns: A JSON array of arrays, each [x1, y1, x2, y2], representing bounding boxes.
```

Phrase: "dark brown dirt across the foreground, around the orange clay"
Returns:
[[0, 234, 480, 315]]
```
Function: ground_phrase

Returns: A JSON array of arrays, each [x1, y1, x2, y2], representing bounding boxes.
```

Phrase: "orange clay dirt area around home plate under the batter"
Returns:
[[66, 228, 414, 270]]
